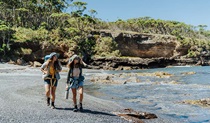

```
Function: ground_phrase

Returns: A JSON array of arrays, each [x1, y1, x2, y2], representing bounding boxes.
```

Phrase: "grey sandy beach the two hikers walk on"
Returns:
[[0, 64, 177, 123]]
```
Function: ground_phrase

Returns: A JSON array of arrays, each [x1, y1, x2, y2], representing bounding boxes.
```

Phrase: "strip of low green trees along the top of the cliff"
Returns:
[[98, 17, 210, 38]]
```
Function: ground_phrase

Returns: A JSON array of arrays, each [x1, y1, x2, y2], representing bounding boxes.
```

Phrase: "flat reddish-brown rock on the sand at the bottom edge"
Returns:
[[113, 108, 158, 123]]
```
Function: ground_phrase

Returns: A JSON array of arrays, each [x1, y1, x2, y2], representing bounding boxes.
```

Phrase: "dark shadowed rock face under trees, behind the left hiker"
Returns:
[[11, 42, 71, 63]]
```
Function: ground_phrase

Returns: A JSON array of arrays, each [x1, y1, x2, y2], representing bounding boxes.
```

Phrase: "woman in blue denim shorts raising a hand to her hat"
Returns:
[[66, 55, 87, 112]]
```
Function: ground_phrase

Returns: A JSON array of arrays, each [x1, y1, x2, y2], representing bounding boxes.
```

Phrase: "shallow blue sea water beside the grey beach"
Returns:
[[86, 66, 210, 123]]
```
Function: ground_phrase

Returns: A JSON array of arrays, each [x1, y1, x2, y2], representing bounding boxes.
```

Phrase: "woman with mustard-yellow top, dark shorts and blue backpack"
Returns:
[[41, 52, 62, 109]]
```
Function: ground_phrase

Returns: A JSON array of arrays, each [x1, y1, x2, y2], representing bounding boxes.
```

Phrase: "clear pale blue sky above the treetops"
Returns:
[[67, 0, 210, 30]]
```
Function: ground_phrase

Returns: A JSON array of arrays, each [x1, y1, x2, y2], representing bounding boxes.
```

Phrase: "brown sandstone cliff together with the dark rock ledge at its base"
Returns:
[[91, 31, 203, 70]]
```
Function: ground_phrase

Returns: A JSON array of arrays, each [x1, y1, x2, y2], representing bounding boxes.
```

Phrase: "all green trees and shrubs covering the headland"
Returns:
[[0, 0, 210, 57]]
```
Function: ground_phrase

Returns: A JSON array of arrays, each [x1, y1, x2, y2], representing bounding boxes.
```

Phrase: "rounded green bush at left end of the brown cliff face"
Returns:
[[95, 37, 120, 57]]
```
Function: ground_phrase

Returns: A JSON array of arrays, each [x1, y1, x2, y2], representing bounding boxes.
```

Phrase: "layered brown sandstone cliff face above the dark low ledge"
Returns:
[[95, 31, 189, 58]]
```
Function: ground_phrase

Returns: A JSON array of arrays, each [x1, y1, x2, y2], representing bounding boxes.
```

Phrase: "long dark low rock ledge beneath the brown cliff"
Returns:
[[90, 57, 197, 70]]
